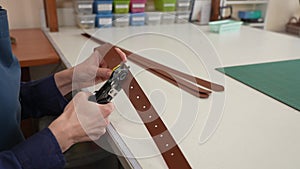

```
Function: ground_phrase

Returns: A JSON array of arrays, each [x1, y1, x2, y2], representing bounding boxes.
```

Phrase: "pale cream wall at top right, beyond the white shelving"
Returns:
[[266, 0, 300, 32]]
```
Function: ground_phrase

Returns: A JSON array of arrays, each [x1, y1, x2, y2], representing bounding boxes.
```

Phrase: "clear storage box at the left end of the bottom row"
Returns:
[[76, 14, 96, 29]]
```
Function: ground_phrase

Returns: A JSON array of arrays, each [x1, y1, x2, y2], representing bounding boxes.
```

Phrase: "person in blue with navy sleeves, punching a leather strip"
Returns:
[[0, 7, 126, 169]]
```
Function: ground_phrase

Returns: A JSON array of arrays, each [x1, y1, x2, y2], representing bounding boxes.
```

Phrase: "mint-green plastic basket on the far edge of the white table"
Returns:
[[208, 20, 243, 33]]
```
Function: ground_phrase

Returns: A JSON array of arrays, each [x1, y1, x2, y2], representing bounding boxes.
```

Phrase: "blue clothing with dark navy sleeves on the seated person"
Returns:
[[0, 7, 67, 169]]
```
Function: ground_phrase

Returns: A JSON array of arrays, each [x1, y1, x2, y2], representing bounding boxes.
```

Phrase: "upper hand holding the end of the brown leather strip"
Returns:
[[54, 43, 126, 95]]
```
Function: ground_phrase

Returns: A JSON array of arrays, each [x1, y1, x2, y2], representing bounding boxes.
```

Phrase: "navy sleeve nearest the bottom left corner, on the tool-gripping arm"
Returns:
[[0, 128, 65, 169]]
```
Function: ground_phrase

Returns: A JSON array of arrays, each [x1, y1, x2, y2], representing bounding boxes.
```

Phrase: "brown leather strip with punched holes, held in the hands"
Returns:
[[99, 48, 191, 169]]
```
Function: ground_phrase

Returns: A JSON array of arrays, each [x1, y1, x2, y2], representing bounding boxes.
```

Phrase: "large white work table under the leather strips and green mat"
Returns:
[[47, 24, 300, 169]]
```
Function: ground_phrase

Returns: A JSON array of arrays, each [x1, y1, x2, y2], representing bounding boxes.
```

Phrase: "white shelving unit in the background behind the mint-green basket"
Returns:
[[220, 0, 269, 29]]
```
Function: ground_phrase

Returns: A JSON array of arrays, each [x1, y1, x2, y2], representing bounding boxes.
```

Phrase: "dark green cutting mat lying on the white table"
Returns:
[[217, 59, 300, 111]]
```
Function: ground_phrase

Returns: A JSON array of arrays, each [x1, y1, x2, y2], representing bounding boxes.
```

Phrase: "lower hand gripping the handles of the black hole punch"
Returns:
[[49, 92, 114, 152]]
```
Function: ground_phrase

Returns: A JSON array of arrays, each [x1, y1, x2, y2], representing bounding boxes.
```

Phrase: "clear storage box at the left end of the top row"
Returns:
[[74, 0, 93, 14]]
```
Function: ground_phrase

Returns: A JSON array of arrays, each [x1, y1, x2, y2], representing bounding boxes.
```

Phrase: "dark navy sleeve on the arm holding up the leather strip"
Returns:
[[20, 75, 68, 119]]
